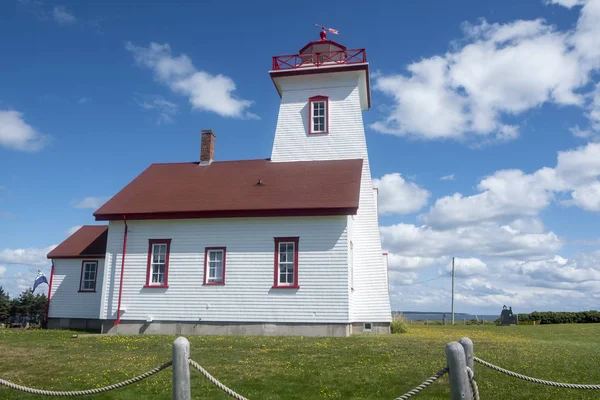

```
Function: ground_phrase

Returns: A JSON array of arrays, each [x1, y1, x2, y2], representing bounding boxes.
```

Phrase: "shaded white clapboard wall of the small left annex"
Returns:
[[48, 258, 104, 319]]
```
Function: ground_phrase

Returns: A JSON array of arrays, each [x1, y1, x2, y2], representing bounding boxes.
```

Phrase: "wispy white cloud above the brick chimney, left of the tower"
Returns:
[[125, 42, 258, 119]]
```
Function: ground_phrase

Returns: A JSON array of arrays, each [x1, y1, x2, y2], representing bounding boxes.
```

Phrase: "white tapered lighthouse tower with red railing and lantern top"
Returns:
[[269, 29, 391, 333]]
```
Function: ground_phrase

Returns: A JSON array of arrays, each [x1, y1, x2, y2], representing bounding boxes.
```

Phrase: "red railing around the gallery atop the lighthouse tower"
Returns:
[[273, 49, 367, 71]]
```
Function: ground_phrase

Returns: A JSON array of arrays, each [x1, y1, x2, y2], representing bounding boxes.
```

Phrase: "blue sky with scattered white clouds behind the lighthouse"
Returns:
[[0, 0, 600, 313]]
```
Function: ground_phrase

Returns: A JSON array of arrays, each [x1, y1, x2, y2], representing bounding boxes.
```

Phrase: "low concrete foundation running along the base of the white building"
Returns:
[[48, 318, 390, 337]]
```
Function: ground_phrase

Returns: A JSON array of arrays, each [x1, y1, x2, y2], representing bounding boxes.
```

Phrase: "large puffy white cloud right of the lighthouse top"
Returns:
[[372, 0, 600, 143]]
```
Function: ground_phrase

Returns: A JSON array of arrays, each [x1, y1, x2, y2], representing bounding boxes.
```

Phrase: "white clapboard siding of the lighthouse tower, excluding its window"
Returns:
[[271, 72, 391, 322]]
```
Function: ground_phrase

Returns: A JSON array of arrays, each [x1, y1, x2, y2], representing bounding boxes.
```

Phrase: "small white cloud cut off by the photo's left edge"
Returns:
[[0, 110, 47, 151]]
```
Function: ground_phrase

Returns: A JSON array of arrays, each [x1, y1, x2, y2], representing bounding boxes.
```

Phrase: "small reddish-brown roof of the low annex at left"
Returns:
[[47, 225, 108, 258]]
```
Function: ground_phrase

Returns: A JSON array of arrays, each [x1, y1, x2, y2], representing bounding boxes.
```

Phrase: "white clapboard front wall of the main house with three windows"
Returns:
[[101, 216, 349, 323]]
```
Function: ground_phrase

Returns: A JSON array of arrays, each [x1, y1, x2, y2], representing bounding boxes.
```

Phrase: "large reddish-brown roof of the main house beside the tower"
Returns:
[[94, 159, 363, 221]]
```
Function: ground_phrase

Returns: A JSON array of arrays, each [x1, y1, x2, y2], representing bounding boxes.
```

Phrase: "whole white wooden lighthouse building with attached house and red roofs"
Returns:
[[48, 28, 391, 336]]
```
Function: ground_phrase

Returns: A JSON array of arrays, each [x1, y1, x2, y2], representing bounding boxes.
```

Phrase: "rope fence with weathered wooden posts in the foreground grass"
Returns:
[[0, 337, 600, 400]]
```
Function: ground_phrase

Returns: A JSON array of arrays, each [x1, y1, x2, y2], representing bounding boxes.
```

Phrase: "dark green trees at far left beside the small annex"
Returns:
[[0, 286, 48, 326]]
